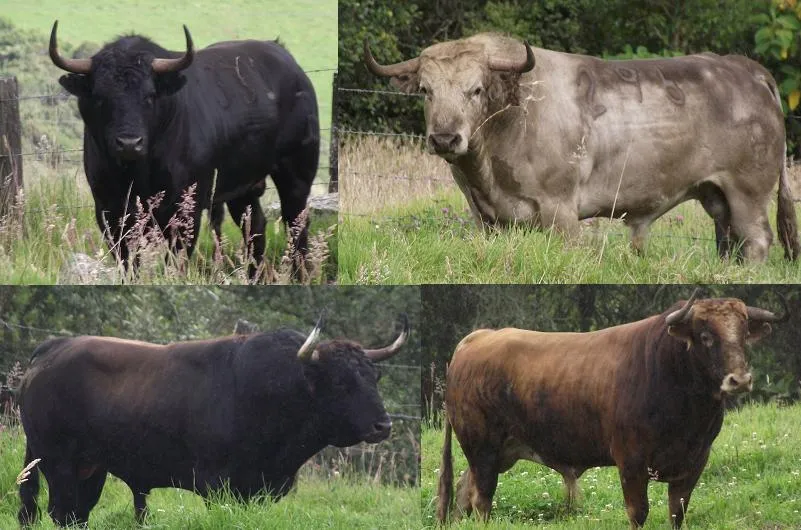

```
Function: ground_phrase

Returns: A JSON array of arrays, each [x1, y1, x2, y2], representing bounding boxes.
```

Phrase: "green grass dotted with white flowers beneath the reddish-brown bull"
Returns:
[[421, 404, 801, 530]]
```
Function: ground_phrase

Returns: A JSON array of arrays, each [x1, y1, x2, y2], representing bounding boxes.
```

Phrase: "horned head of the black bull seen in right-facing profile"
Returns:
[[298, 315, 409, 447]]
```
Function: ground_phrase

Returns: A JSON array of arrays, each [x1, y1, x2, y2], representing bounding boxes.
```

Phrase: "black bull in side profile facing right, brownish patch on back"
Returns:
[[19, 317, 409, 525]]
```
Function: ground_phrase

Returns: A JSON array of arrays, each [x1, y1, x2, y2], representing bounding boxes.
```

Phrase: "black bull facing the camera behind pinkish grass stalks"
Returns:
[[50, 22, 320, 276]]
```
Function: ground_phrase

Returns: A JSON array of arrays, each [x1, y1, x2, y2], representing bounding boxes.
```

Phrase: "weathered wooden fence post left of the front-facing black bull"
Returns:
[[0, 77, 22, 217]]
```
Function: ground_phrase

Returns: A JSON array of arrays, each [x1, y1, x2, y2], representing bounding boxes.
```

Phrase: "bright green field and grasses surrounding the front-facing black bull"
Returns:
[[0, 0, 337, 284]]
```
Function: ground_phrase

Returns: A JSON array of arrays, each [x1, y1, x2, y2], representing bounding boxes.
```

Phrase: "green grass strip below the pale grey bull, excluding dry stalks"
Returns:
[[338, 190, 801, 284]]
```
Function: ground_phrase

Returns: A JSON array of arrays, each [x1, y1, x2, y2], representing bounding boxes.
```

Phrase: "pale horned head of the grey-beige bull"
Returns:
[[364, 36, 534, 158]]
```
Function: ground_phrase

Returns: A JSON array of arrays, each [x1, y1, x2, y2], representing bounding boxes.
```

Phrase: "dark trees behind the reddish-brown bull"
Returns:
[[421, 285, 801, 411]]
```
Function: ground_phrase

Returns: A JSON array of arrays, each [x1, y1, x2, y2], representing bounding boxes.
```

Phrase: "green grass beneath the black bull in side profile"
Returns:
[[0, 429, 420, 530]]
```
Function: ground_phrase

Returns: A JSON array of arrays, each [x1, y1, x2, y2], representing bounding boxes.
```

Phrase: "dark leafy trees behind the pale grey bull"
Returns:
[[337, 0, 797, 138]]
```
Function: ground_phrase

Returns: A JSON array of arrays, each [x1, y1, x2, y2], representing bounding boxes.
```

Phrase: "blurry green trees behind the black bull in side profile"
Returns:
[[0, 286, 421, 483]]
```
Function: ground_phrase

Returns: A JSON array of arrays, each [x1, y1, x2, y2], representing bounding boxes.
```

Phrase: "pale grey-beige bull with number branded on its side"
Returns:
[[364, 34, 801, 261]]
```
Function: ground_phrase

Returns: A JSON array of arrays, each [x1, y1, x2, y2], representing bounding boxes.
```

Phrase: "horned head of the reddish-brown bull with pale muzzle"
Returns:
[[665, 291, 788, 394]]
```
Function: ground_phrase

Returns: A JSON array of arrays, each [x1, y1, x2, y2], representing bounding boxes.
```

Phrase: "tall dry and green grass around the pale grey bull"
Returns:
[[338, 137, 801, 284]]
